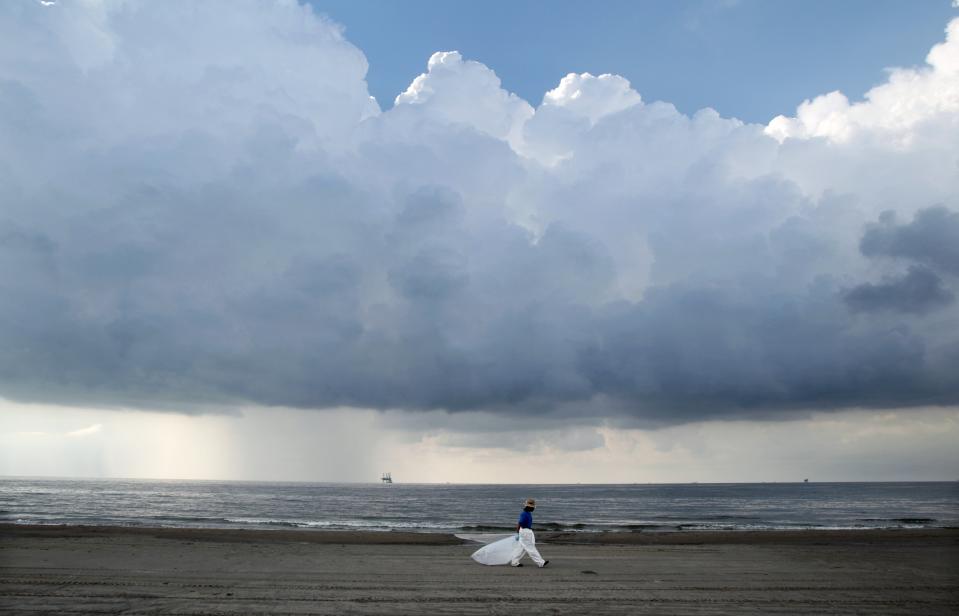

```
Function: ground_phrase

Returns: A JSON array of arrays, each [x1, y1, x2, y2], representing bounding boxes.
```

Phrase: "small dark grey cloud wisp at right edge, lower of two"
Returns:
[[845, 265, 955, 313]]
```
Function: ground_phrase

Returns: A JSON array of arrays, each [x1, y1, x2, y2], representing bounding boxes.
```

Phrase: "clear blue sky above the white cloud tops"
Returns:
[[312, 0, 959, 123]]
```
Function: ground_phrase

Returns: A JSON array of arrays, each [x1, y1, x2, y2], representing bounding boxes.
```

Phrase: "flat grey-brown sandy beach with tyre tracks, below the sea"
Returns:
[[0, 525, 959, 615]]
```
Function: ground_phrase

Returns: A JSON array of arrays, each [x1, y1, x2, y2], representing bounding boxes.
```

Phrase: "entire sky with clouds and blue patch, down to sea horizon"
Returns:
[[0, 0, 959, 483]]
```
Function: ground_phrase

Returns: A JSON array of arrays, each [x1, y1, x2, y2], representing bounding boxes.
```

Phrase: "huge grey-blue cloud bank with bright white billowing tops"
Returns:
[[0, 0, 959, 423]]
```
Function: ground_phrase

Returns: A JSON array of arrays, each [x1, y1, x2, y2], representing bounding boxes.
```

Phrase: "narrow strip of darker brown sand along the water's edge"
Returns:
[[0, 523, 959, 545]]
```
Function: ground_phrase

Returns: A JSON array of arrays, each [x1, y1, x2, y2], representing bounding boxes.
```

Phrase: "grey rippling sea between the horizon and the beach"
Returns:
[[0, 478, 959, 533]]
